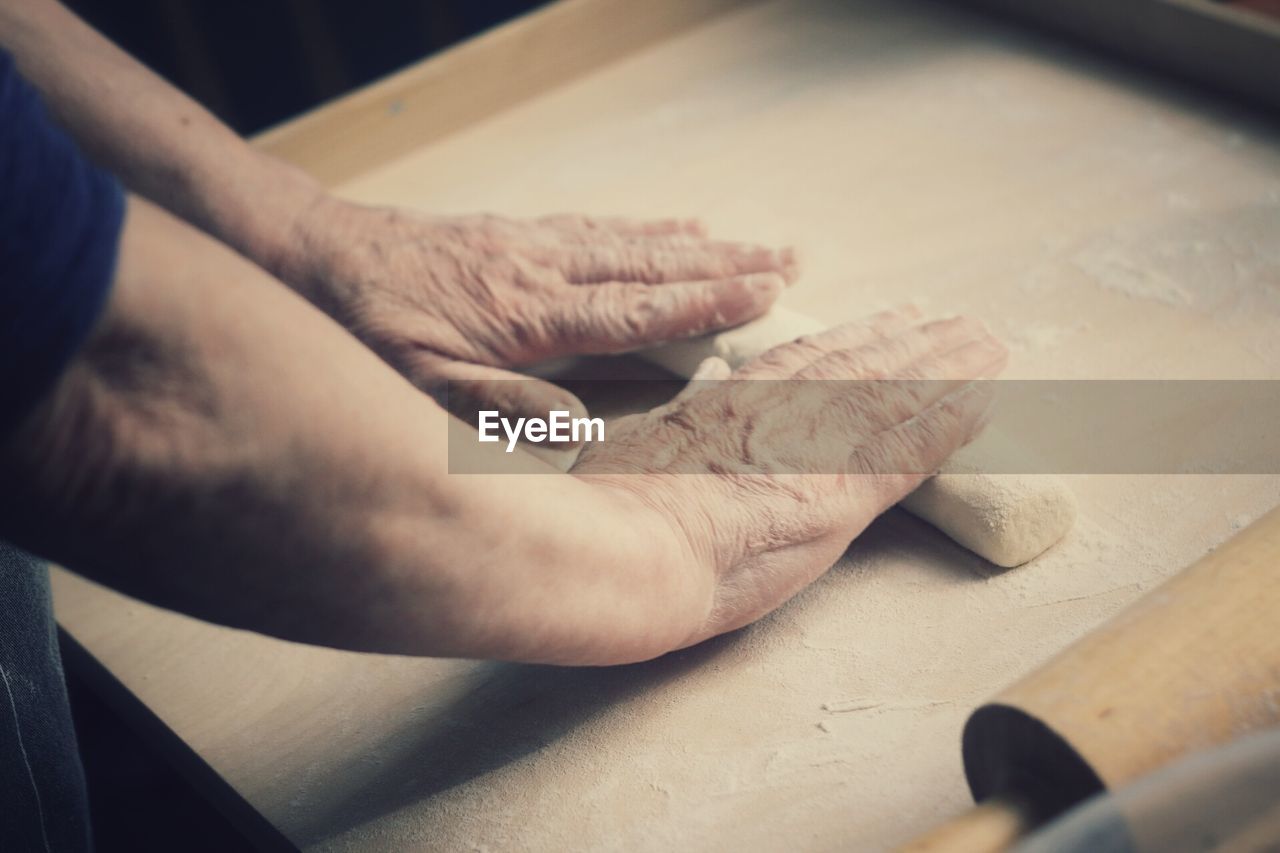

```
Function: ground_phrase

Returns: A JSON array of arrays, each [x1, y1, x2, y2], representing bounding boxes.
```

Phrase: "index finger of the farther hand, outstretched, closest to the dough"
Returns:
[[550, 273, 783, 355]]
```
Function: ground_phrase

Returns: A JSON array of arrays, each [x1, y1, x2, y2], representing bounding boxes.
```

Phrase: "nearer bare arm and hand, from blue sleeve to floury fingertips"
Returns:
[[0, 199, 1005, 663]]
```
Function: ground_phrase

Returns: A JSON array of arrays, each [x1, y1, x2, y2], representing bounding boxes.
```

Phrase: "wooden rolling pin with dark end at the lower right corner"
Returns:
[[904, 508, 1280, 853]]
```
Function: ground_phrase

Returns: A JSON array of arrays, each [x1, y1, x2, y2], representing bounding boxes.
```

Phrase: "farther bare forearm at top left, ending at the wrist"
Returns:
[[0, 0, 319, 270]]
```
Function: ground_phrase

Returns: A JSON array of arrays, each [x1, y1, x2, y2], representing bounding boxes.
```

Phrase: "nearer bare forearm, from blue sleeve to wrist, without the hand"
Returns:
[[0, 195, 710, 662]]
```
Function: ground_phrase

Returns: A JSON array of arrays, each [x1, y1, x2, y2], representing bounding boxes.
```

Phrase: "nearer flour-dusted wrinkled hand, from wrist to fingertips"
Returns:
[[572, 311, 1007, 644]]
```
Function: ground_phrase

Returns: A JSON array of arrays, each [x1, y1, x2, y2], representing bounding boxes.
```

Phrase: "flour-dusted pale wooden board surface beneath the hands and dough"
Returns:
[[55, 0, 1280, 850]]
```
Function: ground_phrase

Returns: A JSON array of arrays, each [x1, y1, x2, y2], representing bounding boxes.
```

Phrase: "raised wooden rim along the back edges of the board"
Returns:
[[255, 0, 1280, 184]]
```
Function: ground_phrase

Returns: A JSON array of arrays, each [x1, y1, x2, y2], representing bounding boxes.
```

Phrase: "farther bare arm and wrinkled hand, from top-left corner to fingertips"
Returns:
[[0, 0, 795, 415]]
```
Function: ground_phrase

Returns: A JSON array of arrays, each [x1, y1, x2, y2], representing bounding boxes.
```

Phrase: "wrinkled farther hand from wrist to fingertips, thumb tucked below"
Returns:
[[279, 196, 796, 416]]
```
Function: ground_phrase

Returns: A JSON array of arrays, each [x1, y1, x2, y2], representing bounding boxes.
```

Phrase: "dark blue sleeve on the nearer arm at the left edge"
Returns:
[[0, 51, 124, 437]]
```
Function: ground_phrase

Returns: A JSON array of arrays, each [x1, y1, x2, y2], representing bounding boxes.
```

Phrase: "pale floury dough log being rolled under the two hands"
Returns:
[[640, 307, 1075, 567]]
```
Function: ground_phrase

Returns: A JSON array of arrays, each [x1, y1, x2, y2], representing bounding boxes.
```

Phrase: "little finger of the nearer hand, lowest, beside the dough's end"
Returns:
[[847, 382, 995, 511]]
